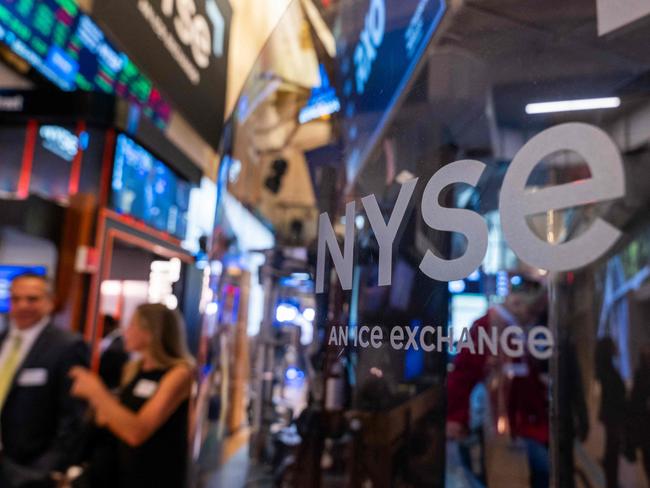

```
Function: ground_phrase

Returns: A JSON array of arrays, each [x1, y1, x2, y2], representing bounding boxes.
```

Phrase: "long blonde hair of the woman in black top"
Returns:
[[124, 303, 194, 382]]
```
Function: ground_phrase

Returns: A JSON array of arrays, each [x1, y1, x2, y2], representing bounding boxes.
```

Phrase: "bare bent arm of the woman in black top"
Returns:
[[71, 365, 192, 446]]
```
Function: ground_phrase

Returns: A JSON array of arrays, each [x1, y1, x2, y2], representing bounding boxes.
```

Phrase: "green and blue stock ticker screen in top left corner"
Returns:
[[0, 0, 170, 127]]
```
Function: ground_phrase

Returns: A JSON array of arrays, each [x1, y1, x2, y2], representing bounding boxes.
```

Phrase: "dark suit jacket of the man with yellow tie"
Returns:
[[0, 325, 88, 473]]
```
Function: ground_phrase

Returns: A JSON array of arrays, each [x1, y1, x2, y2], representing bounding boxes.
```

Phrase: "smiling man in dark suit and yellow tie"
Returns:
[[0, 274, 88, 488]]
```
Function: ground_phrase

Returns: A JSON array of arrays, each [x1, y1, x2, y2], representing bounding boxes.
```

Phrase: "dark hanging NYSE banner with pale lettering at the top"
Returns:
[[93, 0, 232, 147]]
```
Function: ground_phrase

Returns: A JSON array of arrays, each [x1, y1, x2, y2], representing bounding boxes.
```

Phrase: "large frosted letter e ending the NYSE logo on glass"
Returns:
[[499, 123, 625, 271]]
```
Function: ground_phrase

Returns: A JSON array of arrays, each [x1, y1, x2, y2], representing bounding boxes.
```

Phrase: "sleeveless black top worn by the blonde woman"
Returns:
[[117, 369, 189, 488]]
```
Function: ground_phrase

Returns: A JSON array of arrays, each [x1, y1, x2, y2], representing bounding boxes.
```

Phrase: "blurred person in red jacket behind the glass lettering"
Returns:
[[446, 278, 549, 488]]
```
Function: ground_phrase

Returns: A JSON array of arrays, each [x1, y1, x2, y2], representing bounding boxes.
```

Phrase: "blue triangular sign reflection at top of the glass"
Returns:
[[336, 0, 446, 181]]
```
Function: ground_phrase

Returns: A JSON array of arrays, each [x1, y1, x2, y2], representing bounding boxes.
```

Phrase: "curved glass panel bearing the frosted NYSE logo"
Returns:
[[204, 0, 650, 487]]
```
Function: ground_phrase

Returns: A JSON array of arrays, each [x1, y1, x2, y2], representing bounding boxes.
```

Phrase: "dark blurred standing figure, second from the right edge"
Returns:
[[596, 337, 626, 488]]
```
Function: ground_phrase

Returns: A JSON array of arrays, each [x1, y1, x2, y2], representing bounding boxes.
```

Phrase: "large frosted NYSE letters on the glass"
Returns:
[[316, 123, 625, 293]]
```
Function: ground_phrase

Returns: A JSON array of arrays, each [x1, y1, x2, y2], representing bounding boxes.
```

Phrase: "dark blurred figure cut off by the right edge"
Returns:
[[626, 343, 650, 482]]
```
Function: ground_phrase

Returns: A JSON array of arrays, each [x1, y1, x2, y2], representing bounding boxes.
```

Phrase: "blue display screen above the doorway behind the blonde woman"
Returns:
[[112, 134, 192, 239]]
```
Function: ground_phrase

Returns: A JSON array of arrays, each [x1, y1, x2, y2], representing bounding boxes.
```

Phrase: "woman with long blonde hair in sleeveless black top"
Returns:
[[70, 304, 194, 488]]
